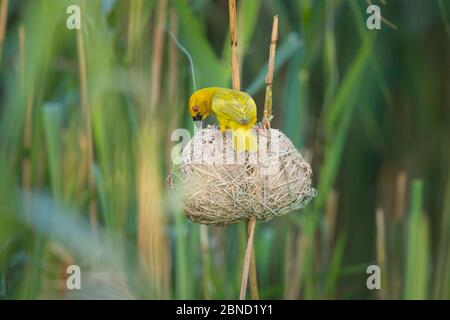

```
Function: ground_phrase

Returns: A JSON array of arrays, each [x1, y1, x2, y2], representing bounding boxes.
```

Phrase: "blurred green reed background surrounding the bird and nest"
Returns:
[[0, 0, 450, 299]]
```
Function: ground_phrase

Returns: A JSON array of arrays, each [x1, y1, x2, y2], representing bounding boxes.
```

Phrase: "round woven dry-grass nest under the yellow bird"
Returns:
[[169, 125, 316, 226]]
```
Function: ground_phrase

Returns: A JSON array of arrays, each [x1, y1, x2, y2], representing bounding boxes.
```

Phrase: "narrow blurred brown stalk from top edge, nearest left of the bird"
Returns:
[[150, 0, 167, 110]]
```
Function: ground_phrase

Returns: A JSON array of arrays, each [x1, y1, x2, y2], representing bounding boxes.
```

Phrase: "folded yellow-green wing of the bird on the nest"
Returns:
[[212, 90, 256, 125]]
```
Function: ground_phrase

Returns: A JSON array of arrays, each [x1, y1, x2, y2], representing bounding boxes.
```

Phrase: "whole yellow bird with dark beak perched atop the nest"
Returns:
[[189, 87, 257, 152]]
